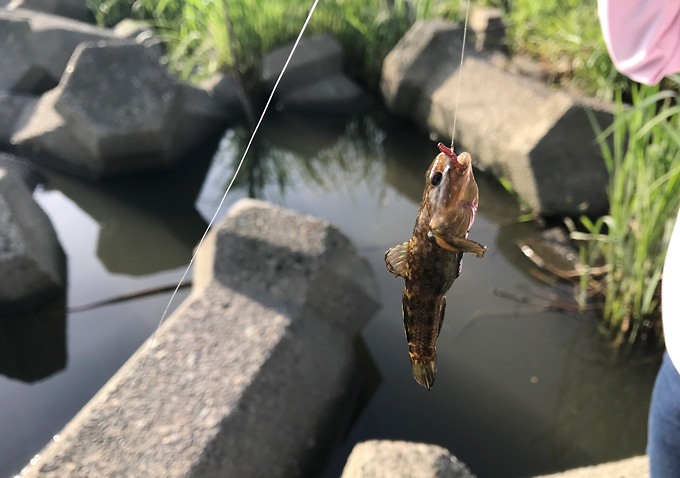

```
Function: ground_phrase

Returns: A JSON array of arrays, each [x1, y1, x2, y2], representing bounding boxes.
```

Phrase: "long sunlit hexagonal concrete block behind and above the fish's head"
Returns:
[[381, 20, 612, 216]]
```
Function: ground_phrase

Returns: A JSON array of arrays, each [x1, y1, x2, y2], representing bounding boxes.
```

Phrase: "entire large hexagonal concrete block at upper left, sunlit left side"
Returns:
[[11, 39, 234, 178]]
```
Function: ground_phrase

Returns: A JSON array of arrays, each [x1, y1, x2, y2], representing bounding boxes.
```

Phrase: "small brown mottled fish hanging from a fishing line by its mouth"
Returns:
[[385, 143, 487, 390]]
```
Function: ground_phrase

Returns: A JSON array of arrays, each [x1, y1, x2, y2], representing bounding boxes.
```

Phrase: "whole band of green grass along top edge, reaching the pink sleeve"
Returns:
[[88, 0, 630, 99]]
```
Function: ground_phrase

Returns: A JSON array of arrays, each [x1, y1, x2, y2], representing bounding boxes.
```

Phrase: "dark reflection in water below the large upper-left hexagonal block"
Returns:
[[41, 144, 212, 276]]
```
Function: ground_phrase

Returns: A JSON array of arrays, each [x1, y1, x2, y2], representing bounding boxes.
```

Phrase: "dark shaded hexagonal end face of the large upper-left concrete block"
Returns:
[[54, 41, 181, 170]]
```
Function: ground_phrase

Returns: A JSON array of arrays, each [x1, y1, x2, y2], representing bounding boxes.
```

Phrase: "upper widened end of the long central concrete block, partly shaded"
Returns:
[[194, 200, 378, 334]]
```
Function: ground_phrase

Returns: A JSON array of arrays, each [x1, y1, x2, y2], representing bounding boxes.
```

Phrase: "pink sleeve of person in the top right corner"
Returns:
[[598, 0, 680, 85]]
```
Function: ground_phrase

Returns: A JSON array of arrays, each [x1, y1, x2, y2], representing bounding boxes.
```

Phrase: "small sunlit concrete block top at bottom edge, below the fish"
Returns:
[[342, 440, 474, 478]]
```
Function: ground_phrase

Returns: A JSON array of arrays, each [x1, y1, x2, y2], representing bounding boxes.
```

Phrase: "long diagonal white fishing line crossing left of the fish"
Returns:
[[87, 0, 319, 472]]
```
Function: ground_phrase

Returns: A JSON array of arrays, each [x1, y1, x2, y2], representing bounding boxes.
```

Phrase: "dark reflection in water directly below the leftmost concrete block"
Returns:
[[0, 298, 66, 382]]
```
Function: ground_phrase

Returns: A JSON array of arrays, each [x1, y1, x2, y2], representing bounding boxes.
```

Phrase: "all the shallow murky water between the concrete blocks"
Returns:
[[0, 112, 658, 477]]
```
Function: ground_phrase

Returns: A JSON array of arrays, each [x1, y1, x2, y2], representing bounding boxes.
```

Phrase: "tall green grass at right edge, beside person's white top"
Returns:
[[572, 82, 680, 344]]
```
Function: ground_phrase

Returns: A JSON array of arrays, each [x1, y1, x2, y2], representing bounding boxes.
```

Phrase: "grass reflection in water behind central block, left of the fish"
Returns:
[[214, 115, 384, 199]]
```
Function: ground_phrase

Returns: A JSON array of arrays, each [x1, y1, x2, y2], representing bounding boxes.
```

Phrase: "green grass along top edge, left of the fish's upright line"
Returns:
[[89, 0, 460, 86]]
